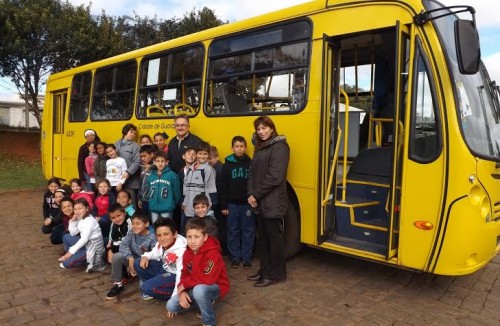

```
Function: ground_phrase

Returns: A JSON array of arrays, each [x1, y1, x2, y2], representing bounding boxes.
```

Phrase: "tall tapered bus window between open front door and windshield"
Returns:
[[409, 50, 441, 163]]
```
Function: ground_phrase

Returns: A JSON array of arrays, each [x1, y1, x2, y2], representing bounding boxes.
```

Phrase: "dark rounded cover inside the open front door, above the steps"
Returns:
[[347, 146, 392, 185]]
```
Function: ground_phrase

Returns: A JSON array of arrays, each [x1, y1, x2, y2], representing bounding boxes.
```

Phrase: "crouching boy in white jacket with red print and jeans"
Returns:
[[134, 218, 187, 300]]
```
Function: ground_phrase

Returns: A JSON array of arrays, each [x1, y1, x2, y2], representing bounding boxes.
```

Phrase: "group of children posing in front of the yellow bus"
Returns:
[[42, 131, 255, 325]]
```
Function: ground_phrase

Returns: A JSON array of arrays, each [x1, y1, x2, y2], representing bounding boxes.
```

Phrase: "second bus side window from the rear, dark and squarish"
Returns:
[[91, 61, 137, 120]]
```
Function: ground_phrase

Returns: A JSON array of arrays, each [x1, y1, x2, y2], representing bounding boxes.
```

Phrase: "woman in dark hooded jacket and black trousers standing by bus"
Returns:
[[247, 116, 290, 287]]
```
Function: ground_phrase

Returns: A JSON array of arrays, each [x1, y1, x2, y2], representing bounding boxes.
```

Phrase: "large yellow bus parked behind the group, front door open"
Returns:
[[42, 0, 500, 275]]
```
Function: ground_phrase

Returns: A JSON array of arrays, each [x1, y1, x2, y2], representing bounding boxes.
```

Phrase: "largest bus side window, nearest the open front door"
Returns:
[[206, 21, 311, 115]]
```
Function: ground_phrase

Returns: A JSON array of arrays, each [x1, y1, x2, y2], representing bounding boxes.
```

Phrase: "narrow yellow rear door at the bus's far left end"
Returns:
[[50, 90, 68, 178]]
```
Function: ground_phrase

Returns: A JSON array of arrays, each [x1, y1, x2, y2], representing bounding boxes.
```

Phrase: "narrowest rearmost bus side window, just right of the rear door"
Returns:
[[69, 71, 92, 122]]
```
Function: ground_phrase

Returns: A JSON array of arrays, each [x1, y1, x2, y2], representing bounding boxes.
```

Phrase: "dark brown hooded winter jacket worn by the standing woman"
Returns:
[[247, 136, 290, 218]]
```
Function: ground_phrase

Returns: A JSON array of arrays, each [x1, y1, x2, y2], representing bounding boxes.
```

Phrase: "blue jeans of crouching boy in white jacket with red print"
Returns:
[[134, 257, 176, 300]]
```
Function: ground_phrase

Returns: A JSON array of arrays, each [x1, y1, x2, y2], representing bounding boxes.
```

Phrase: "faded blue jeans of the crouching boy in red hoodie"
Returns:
[[167, 284, 220, 325]]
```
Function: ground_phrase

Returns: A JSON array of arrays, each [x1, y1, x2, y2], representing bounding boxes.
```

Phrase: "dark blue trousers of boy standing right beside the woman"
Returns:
[[227, 204, 255, 261]]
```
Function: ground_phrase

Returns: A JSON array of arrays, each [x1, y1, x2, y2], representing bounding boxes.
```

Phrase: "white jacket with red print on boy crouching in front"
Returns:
[[142, 234, 187, 295]]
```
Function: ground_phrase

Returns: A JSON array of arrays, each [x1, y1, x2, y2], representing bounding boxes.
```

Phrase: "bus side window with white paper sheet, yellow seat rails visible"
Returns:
[[137, 45, 203, 118]]
